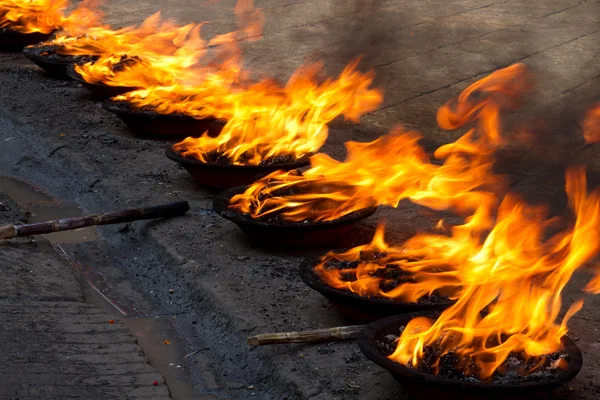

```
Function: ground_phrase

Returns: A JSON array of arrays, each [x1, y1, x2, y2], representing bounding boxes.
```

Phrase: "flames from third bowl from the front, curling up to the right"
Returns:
[[230, 64, 529, 223]]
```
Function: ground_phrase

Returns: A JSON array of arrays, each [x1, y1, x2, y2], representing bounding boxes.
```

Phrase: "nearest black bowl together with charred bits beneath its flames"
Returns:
[[358, 311, 583, 399]]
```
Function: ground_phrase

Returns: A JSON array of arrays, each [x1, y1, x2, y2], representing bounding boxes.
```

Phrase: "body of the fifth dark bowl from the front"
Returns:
[[102, 99, 225, 137]]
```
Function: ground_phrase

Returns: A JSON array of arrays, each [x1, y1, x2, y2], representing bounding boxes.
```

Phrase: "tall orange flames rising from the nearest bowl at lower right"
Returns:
[[389, 169, 600, 380]]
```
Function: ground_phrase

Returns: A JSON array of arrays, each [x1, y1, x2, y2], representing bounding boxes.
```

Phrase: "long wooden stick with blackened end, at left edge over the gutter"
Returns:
[[0, 201, 190, 239]]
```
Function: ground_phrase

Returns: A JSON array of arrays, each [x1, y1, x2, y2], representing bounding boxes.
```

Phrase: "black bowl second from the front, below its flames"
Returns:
[[299, 256, 453, 324]]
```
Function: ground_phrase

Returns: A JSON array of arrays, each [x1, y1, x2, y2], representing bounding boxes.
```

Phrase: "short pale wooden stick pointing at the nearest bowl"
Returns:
[[248, 325, 364, 346]]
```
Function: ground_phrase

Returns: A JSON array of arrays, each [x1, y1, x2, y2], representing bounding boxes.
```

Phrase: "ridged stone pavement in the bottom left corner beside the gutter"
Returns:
[[0, 193, 169, 400]]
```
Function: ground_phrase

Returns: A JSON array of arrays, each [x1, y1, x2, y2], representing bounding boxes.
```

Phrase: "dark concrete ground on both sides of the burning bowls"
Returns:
[[0, 0, 600, 400]]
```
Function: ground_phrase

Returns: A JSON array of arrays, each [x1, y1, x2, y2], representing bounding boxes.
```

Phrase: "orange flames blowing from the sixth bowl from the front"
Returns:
[[74, 0, 263, 90]]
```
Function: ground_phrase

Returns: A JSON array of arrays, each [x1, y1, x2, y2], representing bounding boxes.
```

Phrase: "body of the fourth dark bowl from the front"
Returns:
[[165, 148, 309, 189]]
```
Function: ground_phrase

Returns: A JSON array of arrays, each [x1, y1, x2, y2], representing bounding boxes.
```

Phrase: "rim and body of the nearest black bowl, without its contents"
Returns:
[[358, 311, 583, 400]]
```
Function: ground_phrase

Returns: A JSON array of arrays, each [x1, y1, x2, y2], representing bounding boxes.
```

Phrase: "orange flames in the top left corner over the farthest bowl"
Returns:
[[0, 0, 102, 33]]
